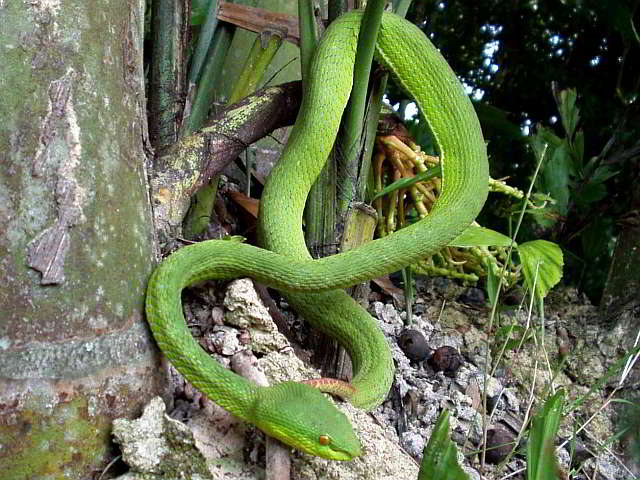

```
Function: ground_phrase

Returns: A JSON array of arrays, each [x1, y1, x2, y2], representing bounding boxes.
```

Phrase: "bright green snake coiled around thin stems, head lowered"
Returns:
[[146, 11, 488, 460]]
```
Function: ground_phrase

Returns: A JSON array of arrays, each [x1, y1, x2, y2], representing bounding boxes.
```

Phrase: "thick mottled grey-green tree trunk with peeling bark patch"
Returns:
[[0, 0, 164, 479]]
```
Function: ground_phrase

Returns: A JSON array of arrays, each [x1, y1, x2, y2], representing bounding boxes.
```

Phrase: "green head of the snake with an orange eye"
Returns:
[[253, 382, 362, 460]]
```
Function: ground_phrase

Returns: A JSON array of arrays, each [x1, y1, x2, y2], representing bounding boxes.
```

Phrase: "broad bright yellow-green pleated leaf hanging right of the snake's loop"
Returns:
[[518, 240, 564, 299]]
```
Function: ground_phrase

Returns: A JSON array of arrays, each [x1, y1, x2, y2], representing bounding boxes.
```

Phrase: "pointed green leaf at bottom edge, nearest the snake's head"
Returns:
[[418, 410, 469, 480]]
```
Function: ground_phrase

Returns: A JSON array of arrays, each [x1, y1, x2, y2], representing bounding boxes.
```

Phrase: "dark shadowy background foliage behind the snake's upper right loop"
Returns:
[[382, 0, 640, 303]]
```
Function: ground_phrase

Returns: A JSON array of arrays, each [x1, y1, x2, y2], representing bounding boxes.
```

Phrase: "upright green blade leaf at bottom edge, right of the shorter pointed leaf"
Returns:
[[527, 390, 564, 480]]
